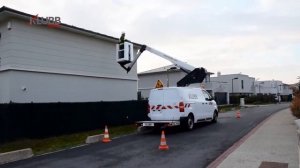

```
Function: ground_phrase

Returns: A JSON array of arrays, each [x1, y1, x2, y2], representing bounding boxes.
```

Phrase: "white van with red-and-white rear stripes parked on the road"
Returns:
[[138, 87, 218, 130]]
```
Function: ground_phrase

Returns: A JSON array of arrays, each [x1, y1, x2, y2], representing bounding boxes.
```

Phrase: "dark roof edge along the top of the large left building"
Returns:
[[0, 6, 141, 46]]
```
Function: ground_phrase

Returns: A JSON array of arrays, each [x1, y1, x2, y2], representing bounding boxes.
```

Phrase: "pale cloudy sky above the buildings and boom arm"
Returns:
[[0, 0, 300, 84]]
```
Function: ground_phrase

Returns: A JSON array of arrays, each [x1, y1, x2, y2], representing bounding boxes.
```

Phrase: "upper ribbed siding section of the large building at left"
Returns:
[[3, 20, 137, 79]]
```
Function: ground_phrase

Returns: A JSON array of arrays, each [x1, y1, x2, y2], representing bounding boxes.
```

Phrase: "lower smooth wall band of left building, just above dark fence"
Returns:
[[0, 71, 137, 103]]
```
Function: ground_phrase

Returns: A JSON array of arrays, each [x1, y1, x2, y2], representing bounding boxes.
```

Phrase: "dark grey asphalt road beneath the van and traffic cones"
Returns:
[[0, 104, 288, 168]]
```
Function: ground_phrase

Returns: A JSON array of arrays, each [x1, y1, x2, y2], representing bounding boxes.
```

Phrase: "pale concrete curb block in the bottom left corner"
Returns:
[[0, 148, 33, 165]]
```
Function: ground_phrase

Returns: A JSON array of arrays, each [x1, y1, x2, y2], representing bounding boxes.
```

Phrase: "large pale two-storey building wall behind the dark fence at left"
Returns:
[[0, 7, 137, 103]]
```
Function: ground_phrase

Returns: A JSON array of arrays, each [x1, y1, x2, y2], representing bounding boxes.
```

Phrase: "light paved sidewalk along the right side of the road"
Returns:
[[218, 109, 299, 168]]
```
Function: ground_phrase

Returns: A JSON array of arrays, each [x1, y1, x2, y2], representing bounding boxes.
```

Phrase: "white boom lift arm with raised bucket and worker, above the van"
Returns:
[[117, 33, 207, 86]]
